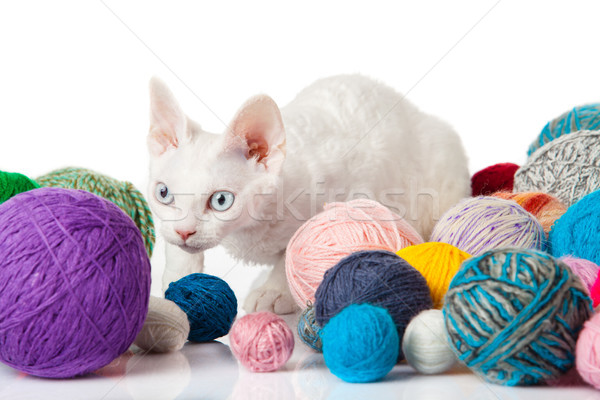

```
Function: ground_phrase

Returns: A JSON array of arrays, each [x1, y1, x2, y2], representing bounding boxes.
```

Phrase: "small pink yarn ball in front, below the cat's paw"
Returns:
[[229, 311, 294, 372]]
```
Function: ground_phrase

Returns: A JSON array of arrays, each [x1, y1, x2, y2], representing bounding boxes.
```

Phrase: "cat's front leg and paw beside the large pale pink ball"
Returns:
[[244, 253, 298, 314]]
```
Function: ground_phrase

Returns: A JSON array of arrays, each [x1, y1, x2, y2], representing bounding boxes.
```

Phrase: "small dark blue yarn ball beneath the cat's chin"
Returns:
[[165, 274, 237, 342]]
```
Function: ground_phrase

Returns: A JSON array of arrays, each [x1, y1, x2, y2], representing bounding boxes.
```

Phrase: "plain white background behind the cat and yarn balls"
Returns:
[[0, 0, 600, 397]]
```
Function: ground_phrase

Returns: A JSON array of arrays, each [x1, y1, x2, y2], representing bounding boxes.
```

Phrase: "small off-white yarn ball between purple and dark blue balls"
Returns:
[[133, 296, 190, 353]]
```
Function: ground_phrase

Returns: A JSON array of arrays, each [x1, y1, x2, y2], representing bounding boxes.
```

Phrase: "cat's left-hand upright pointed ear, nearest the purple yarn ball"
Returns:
[[148, 77, 189, 156]]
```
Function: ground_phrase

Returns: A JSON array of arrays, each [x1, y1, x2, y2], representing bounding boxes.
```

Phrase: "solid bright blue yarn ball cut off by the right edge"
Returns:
[[549, 190, 600, 264]]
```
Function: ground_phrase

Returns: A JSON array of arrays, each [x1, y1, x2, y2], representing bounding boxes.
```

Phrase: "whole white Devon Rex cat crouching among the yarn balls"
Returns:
[[148, 75, 469, 314]]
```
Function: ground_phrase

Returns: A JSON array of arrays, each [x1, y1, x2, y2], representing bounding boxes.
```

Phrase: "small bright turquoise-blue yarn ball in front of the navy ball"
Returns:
[[321, 304, 400, 383]]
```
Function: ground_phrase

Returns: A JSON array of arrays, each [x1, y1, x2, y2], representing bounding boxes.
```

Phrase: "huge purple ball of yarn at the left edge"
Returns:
[[0, 188, 150, 378]]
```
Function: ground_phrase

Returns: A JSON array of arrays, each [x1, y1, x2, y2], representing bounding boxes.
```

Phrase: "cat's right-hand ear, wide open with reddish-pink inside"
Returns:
[[224, 95, 285, 173]]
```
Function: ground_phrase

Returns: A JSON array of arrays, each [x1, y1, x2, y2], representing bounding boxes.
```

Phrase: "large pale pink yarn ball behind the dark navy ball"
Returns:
[[285, 199, 423, 308]]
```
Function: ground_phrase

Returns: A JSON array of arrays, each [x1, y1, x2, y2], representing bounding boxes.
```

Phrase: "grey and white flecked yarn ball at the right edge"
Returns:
[[514, 131, 600, 206]]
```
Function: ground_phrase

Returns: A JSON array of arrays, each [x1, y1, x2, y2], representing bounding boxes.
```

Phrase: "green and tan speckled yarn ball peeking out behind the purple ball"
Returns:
[[36, 167, 155, 257]]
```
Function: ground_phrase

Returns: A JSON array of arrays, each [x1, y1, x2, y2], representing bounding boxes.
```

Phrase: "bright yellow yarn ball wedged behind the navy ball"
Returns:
[[396, 242, 471, 308]]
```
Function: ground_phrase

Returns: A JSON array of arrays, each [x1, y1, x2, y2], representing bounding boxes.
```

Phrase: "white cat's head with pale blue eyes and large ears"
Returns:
[[148, 79, 285, 252]]
